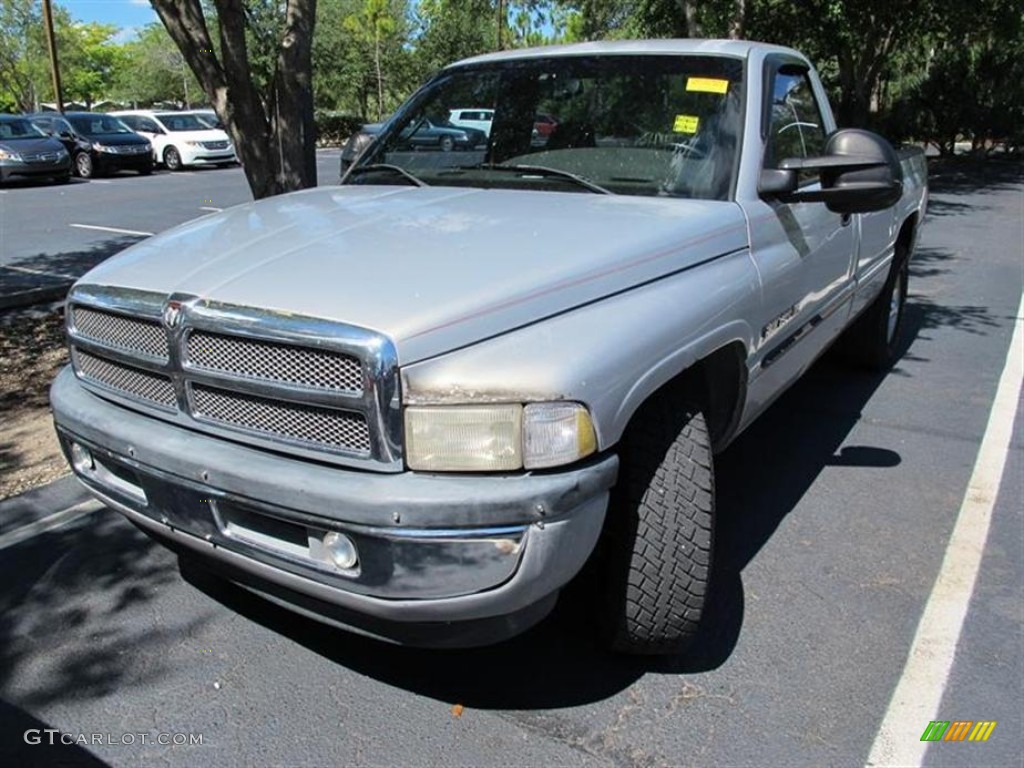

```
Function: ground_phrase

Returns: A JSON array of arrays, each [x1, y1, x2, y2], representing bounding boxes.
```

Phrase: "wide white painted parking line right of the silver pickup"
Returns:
[[867, 290, 1024, 766]]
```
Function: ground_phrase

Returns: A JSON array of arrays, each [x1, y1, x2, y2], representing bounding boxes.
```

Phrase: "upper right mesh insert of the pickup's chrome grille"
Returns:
[[185, 331, 362, 394]]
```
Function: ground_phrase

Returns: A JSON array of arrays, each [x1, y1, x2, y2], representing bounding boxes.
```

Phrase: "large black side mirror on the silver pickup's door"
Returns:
[[758, 128, 903, 214]]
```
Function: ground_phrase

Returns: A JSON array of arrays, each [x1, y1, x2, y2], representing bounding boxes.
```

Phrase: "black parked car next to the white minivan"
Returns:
[[29, 112, 153, 178]]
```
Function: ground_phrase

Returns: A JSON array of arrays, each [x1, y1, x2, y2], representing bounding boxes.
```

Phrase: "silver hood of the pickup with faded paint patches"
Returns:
[[80, 185, 746, 364]]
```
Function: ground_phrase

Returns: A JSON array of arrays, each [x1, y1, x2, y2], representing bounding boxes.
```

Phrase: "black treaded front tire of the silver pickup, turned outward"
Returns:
[[602, 397, 715, 654]]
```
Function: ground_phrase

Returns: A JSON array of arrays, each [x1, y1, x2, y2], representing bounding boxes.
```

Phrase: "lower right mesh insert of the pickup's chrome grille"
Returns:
[[191, 384, 370, 455]]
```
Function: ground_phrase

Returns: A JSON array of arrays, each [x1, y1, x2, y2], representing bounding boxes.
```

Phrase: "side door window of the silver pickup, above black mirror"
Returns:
[[765, 67, 825, 184]]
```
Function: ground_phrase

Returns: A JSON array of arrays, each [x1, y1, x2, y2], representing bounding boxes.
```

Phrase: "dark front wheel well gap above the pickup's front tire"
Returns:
[[627, 341, 746, 452]]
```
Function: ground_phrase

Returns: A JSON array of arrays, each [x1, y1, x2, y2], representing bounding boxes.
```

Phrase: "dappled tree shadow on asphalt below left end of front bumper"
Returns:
[[0, 509, 205, 712]]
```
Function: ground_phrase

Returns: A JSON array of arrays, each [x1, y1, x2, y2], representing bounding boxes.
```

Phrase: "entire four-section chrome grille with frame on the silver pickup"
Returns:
[[68, 285, 403, 472]]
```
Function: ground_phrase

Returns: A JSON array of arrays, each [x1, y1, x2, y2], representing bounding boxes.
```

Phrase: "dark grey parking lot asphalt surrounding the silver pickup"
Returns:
[[0, 160, 1024, 766]]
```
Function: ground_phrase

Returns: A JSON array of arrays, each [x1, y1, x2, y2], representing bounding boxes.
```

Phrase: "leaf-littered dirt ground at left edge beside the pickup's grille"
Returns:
[[0, 307, 69, 499]]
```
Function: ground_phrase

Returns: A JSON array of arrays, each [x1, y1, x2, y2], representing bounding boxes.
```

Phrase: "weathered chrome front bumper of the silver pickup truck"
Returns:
[[51, 369, 617, 645]]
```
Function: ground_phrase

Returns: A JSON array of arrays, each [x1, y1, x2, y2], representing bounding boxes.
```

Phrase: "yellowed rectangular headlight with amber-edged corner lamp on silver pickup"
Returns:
[[406, 402, 597, 472]]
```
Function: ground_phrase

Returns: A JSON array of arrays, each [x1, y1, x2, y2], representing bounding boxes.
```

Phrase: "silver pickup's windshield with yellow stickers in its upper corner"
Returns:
[[346, 55, 743, 200]]
